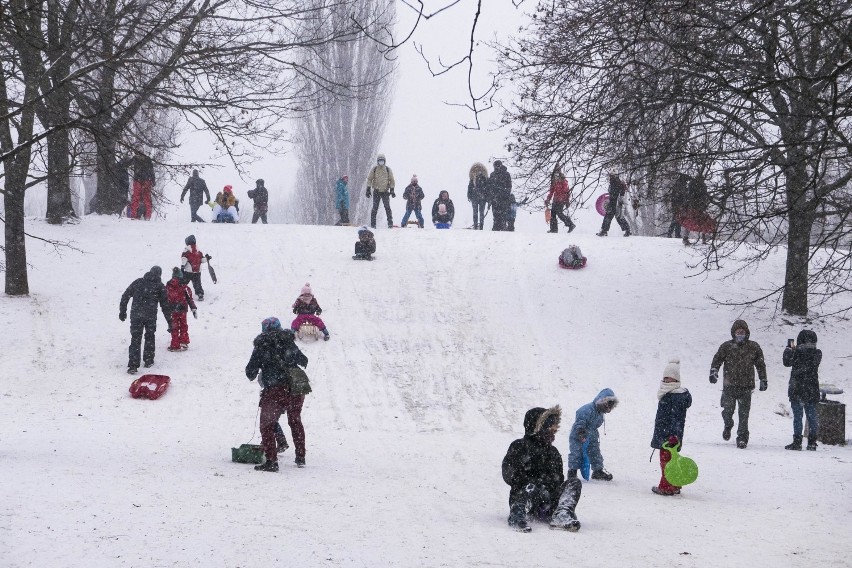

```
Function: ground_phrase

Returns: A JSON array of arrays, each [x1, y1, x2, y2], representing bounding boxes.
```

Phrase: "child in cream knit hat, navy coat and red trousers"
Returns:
[[651, 359, 692, 495]]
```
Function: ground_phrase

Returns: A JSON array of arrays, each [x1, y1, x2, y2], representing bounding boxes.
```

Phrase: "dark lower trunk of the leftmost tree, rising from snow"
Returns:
[[3, 158, 30, 296]]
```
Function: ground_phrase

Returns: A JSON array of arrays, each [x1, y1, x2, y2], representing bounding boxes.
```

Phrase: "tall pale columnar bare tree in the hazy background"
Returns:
[[291, 0, 395, 225]]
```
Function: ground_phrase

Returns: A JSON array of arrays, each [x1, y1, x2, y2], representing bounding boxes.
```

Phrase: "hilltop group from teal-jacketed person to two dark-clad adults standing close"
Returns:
[[334, 154, 518, 231]]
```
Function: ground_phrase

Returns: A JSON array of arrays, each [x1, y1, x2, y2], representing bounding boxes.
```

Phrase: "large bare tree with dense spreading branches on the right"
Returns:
[[504, 0, 852, 315]]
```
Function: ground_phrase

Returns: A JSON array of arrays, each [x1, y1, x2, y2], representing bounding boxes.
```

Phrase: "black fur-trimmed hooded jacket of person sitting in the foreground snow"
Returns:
[[503, 406, 565, 494]]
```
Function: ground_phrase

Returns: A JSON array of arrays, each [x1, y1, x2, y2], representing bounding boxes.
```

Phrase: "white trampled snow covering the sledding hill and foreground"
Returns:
[[0, 211, 852, 567]]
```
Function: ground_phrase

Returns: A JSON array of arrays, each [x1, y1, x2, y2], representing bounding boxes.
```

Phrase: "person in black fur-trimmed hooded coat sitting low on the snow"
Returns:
[[503, 406, 583, 532]]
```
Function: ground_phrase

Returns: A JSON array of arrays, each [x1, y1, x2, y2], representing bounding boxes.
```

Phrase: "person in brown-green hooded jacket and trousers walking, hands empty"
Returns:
[[710, 320, 769, 450]]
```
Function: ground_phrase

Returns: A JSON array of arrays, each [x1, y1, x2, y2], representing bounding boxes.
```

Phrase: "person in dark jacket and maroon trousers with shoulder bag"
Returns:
[[246, 317, 308, 472]]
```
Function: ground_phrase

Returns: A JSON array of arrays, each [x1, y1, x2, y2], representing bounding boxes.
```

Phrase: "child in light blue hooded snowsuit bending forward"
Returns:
[[568, 389, 618, 481]]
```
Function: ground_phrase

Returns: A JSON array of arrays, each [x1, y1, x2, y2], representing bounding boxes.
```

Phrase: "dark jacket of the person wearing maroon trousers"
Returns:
[[246, 329, 308, 388]]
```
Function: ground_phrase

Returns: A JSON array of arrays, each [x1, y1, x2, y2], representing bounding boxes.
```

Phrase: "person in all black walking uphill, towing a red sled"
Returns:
[[118, 266, 170, 375]]
